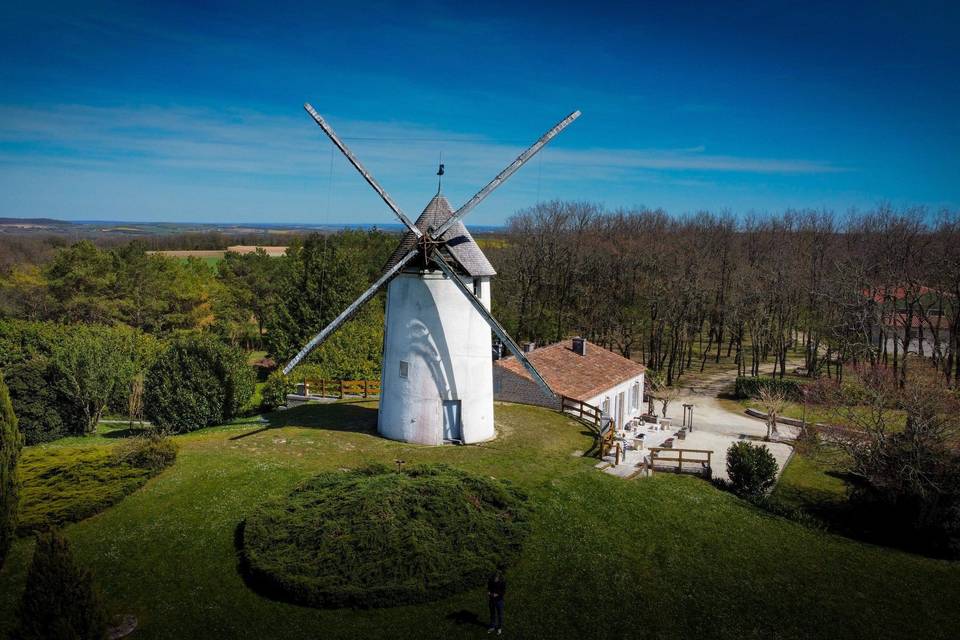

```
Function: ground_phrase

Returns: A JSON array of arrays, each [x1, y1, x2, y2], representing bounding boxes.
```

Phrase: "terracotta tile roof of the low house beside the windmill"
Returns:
[[493, 340, 646, 400]]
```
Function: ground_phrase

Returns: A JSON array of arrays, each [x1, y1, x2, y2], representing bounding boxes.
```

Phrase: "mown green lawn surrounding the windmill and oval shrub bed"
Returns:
[[0, 403, 960, 638]]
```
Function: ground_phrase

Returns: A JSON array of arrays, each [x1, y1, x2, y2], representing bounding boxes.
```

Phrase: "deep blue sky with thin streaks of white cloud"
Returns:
[[0, 1, 960, 224]]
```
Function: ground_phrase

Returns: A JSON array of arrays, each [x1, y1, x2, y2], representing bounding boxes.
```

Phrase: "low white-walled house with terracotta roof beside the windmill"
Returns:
[[493, 338, 646, 425]]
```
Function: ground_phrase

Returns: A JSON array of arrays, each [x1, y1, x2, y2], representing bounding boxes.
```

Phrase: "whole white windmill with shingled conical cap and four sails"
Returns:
[[283, 104, 580, 444]]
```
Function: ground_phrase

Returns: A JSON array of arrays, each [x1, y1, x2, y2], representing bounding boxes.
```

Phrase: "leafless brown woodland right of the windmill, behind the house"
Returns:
[[488, 201, 960, 384]]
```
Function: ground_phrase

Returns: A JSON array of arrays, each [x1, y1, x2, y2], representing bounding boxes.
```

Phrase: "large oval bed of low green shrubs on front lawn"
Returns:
[[242, 465, 527, 607]]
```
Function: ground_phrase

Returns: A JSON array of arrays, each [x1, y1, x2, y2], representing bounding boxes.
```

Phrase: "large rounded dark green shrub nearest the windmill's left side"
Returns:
[[144, 336, 254, 432]]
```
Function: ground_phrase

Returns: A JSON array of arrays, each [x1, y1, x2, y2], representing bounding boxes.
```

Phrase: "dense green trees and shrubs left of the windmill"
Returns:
[[0, 231, 395, 444]]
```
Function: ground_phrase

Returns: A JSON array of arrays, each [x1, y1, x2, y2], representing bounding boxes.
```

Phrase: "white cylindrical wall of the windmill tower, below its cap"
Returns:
[[377, 273, 496, 444]]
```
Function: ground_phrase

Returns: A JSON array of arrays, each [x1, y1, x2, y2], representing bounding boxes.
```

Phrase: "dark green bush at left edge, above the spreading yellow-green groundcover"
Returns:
[[6, 357, 84, 445]]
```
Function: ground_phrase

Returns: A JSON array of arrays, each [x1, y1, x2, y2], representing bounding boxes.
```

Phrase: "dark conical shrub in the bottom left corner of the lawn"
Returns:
[[13, 531, 107, 640]]
